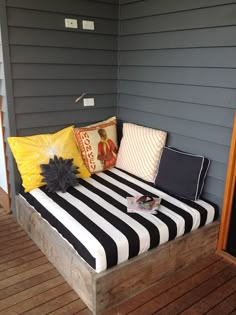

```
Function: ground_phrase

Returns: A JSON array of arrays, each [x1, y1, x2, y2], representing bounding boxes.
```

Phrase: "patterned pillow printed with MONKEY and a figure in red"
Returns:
[[74, 117, 118, 173]]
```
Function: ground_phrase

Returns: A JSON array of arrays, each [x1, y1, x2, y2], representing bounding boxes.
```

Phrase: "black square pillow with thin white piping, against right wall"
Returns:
[[155, 147, 210, 200]]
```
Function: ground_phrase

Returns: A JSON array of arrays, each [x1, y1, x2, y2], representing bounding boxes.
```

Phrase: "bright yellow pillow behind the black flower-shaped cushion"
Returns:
[[7, 126, 90, 192]]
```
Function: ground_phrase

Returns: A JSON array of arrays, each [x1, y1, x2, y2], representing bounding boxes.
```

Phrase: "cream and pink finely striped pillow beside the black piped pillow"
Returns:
[[116, 123, 167, 182]]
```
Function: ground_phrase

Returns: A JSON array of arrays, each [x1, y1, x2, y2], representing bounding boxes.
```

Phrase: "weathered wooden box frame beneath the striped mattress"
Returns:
[[16, 196, 219, 314]]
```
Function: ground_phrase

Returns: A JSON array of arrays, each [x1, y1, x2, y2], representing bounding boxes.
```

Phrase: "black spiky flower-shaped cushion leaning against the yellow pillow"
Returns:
[[40, 155, 79, 192]]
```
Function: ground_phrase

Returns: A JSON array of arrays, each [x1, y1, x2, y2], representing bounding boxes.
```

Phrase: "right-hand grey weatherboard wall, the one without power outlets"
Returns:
[[118, 0, 236, 209]]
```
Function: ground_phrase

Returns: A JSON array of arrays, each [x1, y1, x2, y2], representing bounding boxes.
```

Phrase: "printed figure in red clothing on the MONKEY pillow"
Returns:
[[97, 128, 118, 170]]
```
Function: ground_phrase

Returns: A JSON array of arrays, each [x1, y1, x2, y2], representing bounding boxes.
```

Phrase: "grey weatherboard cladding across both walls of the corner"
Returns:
[[0, 0, 236, 212]]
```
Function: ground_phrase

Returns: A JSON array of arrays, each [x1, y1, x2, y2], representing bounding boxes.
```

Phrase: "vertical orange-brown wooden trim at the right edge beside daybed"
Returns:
[[217, 113, 236, 251]]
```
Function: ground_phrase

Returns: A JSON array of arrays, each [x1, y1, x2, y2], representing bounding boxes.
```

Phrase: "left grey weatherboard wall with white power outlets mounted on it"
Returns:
[[6, 0, 118, 136]]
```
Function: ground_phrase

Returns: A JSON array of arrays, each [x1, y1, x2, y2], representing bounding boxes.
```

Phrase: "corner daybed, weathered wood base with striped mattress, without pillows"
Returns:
[[16, 168, 219, 314]]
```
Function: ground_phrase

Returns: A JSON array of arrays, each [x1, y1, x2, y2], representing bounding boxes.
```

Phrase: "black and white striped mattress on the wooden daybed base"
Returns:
[[21, 168, 218, 272]]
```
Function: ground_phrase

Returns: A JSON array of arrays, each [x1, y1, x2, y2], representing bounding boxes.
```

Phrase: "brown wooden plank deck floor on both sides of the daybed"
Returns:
[[0, 210, 236, 315]]
